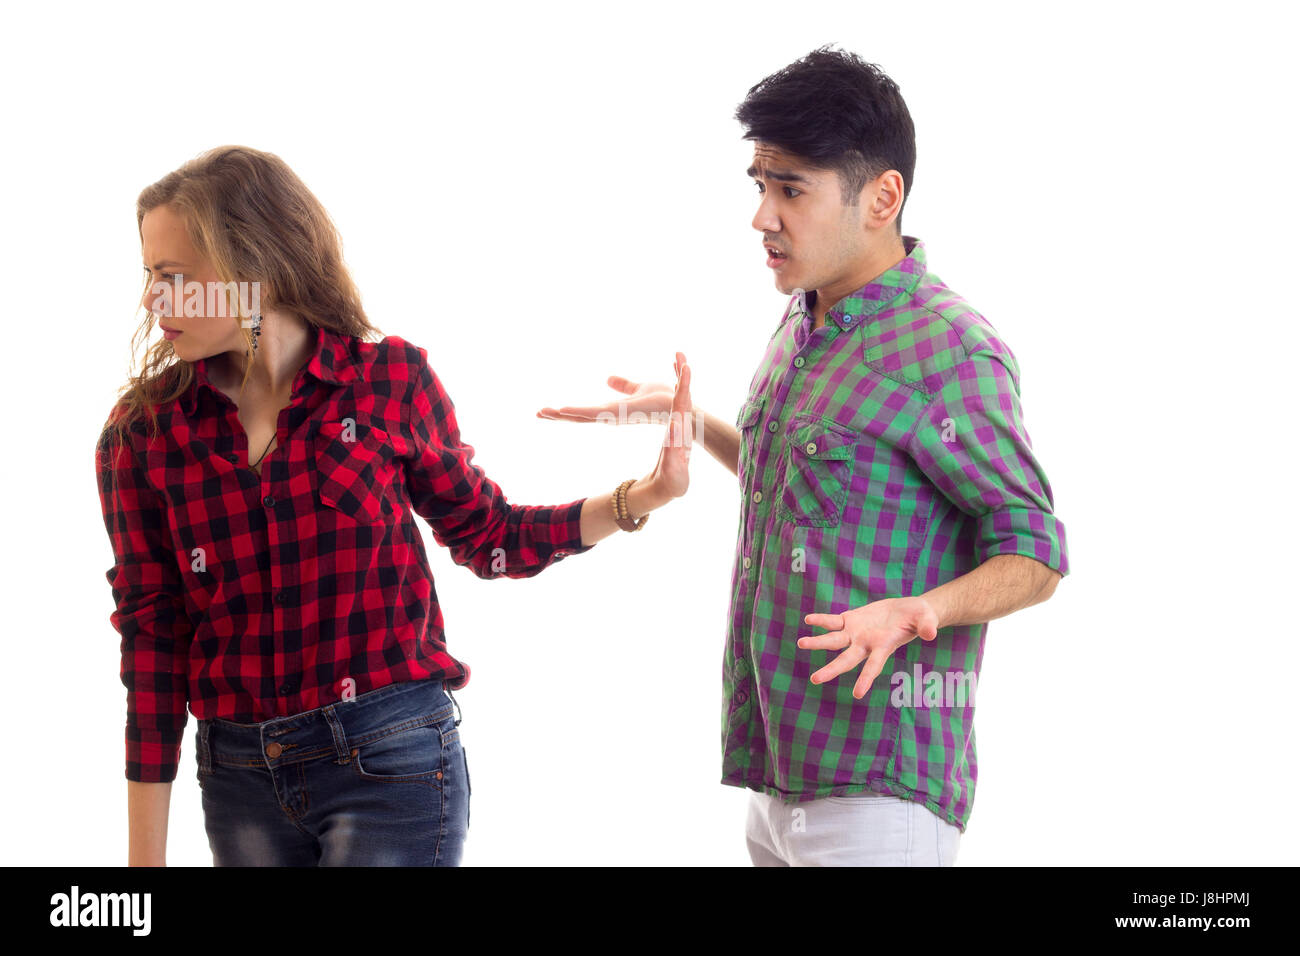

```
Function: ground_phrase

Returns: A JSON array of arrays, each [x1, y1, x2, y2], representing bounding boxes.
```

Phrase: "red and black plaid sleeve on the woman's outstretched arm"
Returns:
[[406, 347, 594, 578]]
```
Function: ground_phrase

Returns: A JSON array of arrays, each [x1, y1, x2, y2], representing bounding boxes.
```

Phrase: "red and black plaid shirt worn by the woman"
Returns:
[[95, 329, 592, 782]]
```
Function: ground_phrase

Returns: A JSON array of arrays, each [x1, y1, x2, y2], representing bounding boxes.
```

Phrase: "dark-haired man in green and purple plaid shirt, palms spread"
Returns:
[[541, 48, 1067, 866]]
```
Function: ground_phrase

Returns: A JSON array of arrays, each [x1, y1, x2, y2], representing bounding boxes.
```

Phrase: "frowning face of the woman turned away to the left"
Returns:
[[140, 206, 244, 362]]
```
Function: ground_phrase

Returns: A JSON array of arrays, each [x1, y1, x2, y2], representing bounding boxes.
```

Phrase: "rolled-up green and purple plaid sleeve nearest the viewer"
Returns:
[[907, 352, 1069, 575]]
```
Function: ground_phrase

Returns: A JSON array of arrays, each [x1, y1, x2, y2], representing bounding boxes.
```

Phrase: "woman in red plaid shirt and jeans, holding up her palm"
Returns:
[[96, 141, 692, 866]]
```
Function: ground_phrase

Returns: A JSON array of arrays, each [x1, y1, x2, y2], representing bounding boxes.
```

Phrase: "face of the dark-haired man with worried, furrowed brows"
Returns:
[[748, 143, 868, 295]]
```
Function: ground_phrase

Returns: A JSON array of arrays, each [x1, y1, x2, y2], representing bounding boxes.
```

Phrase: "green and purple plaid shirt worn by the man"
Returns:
[[723, 235, 1067, 831]]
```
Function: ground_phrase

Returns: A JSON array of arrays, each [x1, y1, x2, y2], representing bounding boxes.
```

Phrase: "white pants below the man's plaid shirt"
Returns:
[[745, 791, 962, 866]]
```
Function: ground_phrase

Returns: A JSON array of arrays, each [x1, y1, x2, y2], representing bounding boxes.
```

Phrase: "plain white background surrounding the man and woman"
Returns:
[[0, 0, 1300, 865]]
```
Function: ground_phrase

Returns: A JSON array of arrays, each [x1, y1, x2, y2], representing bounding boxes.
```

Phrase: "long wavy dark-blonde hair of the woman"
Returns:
[[100, 146, 380, 460]]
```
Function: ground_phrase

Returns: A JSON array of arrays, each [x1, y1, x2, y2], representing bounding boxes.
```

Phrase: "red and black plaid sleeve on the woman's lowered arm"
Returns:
[[95, 432, 194, 783]]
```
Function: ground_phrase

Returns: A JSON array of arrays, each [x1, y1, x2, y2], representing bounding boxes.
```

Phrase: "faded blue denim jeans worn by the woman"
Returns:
[[196, 680, 469, 866]]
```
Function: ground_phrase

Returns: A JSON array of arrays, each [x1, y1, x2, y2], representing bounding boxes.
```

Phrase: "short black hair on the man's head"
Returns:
[[736, 46, 917, 234]]
